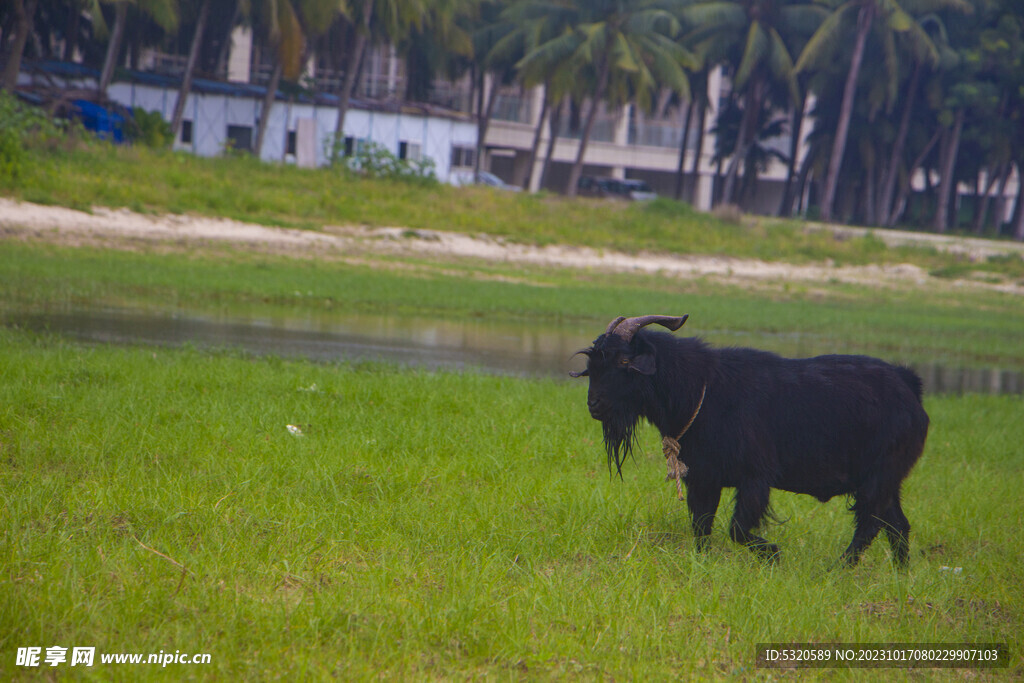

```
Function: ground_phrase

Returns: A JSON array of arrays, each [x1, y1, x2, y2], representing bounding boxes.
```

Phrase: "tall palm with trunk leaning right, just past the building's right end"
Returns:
[[796, 0, 971, 221]]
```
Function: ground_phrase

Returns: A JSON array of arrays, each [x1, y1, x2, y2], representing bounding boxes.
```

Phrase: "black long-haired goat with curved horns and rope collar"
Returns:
[[571, 315, 928, 565]]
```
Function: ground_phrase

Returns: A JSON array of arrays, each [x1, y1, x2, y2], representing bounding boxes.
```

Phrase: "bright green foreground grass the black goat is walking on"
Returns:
[[0, 331, 1024, 680]]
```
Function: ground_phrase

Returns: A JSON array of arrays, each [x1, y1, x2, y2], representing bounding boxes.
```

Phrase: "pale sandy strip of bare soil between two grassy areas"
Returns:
[[0, 198, 1024, 294]]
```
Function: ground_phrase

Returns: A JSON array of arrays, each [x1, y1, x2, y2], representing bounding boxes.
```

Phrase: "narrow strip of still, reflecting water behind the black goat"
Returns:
[[2, 309, 1024, 394]]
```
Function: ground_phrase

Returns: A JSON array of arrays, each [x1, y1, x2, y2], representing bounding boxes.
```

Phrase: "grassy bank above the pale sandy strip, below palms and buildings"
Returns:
[[0, 143, 1024, 280]]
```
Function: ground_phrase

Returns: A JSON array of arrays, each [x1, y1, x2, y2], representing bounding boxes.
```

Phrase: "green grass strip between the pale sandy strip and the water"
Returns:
[[6, 237, 1024, 369]]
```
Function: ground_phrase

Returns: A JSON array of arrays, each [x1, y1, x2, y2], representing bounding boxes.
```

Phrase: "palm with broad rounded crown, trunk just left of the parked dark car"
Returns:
[[518, 0, 697, 197]]
